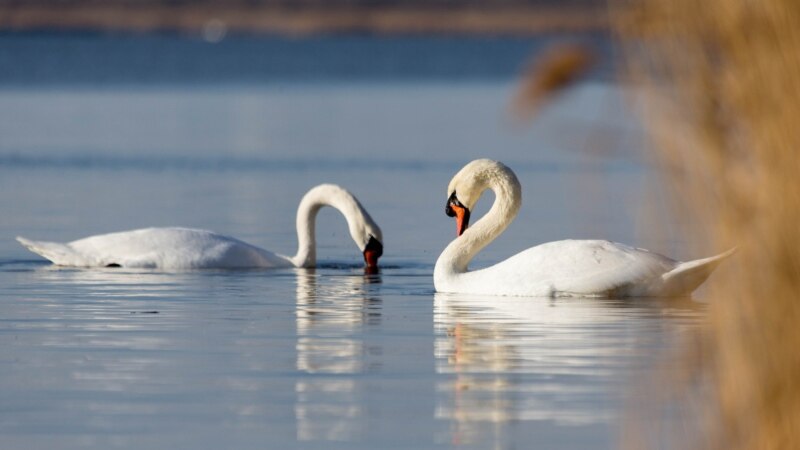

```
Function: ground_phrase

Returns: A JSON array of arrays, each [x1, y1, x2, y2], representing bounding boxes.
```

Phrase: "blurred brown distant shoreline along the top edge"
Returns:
[[0, 4, 609, 38]]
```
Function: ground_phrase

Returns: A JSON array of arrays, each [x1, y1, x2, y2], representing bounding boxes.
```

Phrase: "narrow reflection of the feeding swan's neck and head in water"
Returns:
[[295, 269, 382, 441]]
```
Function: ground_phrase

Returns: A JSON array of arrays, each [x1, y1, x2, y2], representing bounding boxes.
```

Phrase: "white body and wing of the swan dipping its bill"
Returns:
[[66, 228, 291, 269]]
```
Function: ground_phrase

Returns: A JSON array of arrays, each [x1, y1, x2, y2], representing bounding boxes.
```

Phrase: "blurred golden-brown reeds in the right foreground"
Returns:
[[617, 0, 800, 449]]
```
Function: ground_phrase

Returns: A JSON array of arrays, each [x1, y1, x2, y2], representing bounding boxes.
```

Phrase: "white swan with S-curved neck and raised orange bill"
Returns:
[[433, 159, 734, 297]]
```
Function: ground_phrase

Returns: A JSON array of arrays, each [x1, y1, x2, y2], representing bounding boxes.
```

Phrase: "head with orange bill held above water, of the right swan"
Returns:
[[444, 159, 518, 236]]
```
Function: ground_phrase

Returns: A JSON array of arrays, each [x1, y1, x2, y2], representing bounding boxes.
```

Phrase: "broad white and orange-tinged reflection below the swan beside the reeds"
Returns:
[[434, 294, 702, 444]]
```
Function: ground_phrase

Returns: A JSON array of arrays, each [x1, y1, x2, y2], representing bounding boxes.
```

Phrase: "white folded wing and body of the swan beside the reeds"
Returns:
[[477, 240, 676, 296]]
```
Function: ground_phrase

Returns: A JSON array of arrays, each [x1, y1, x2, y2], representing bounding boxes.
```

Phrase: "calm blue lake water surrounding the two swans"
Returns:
[[0, 33, 703, 449]]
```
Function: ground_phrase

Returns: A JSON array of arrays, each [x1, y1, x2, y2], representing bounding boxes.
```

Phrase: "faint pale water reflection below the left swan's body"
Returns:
[[16, 266, 200, 400]]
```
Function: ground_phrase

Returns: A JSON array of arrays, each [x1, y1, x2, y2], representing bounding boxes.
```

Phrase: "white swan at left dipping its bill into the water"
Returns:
[[17, 184, 383, 270]]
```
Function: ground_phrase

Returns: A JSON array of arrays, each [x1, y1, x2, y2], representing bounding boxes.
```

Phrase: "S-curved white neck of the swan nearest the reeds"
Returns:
[[434, 170, 522, 275]]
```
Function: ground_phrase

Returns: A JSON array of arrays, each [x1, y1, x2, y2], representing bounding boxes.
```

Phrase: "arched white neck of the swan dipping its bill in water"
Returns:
[[290, 185, 366, 267]]
